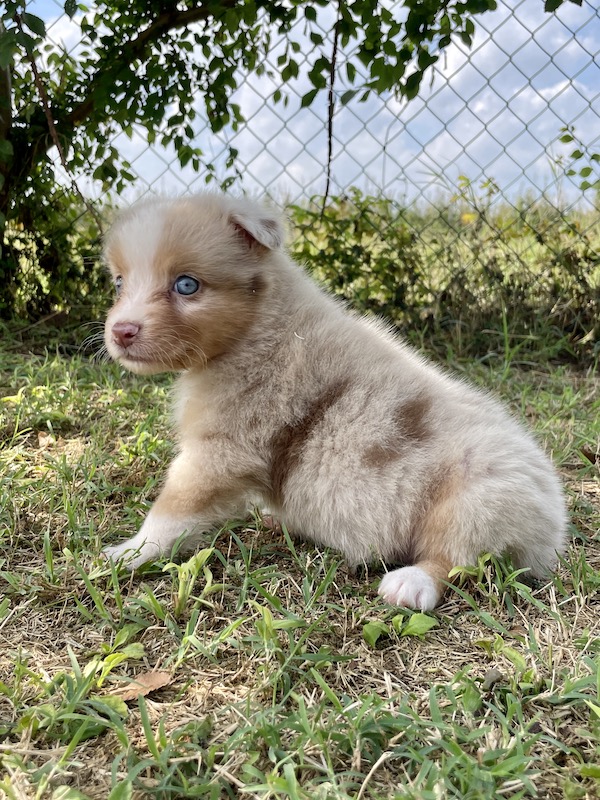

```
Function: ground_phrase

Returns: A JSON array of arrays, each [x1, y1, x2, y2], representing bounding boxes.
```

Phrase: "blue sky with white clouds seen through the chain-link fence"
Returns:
[[28, 0, 600, 209]]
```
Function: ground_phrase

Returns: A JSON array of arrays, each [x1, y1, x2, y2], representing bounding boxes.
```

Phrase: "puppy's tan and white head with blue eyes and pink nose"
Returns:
[[104, 193, 284, 375]]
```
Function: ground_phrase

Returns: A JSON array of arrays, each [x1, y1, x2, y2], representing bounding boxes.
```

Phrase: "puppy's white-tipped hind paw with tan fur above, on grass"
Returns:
[[378, 556, 452, 611]]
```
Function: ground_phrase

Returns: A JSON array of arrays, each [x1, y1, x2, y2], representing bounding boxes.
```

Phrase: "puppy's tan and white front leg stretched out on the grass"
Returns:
[[102, 453, 240, 570]]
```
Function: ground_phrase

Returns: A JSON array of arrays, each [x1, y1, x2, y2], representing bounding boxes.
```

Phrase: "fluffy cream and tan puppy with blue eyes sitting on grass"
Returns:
[[104, 193, 566, 610]]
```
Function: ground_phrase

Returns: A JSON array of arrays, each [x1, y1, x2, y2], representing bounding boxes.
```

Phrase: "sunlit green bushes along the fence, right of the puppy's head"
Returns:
[[290, 184, 600, 361]]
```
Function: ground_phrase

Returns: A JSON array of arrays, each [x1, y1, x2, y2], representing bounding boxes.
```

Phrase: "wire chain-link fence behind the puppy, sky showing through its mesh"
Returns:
[[12, 0, 600, 356]]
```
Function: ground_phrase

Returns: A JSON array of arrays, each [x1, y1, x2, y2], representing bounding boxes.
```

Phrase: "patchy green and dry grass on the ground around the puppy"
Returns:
[[0, 328, 600, 800]]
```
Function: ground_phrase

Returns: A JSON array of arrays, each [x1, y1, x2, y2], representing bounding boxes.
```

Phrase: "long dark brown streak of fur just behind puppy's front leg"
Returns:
[[270, 380, 348, 503]]
